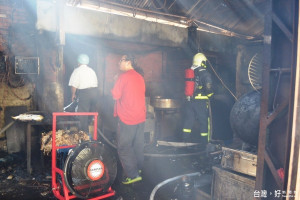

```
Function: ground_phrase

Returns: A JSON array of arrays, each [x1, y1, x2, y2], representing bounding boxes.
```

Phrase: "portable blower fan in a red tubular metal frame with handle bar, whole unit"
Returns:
[[52, 112, 117, 200]]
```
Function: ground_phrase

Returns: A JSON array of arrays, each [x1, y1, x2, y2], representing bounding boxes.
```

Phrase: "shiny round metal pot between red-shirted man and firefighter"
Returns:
[[150, 96, 180, 109]]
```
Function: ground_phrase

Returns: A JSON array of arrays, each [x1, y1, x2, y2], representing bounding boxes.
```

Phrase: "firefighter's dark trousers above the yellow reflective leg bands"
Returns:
[[183, 99, 208, 133]]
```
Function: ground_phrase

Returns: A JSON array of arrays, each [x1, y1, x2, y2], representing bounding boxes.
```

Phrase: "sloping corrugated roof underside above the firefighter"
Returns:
[[67, 0, 266, 40]]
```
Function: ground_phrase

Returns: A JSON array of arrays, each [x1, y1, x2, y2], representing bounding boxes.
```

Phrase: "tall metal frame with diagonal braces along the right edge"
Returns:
[[255, 0, 298, 199]]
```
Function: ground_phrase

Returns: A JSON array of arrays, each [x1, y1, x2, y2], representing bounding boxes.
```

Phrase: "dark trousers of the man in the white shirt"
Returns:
[[77, 88, 97, 133]]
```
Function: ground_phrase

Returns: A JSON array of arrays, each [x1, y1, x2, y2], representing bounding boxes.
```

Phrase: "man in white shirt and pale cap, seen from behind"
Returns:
[[69, 54, 98, 133]]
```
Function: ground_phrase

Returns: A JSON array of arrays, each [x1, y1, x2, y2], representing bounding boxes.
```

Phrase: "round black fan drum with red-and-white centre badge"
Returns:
[[63, 141, 117, 199]]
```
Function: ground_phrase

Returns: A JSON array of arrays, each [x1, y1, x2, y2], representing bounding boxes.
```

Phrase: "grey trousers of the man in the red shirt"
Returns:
[[117, 120, 145, 178]]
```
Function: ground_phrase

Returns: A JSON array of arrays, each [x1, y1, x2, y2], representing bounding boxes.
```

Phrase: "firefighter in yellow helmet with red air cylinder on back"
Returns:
[[182, 53, 213, 142]]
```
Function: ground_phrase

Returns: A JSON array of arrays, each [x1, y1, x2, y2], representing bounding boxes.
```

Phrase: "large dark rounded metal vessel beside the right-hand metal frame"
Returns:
[[230, 91, 261, 146]]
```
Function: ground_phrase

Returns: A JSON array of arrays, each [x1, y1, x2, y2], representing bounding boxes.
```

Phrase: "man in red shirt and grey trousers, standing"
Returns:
[[111, 55, 146, 184]]
